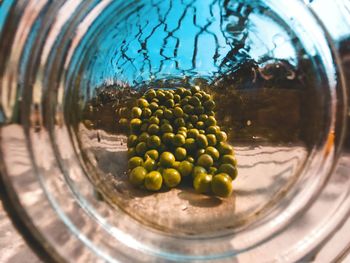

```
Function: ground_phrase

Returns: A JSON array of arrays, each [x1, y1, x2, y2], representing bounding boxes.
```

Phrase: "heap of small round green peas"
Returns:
[[124, 86, 237, 197]]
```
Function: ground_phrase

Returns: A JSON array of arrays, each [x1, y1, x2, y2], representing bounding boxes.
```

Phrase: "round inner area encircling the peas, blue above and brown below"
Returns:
[[67, 1, 328, 235]]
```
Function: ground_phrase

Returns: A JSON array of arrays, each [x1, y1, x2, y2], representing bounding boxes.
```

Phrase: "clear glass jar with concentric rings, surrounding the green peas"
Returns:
[[0, 0, 350, 262]]
